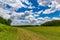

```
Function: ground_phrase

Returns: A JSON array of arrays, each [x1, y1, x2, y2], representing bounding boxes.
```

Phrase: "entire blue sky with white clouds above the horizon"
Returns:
[[0, 0, 60, 25]]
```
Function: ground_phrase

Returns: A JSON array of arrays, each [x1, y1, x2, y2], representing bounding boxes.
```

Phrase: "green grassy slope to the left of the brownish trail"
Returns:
[[0, 24, 17, 40]]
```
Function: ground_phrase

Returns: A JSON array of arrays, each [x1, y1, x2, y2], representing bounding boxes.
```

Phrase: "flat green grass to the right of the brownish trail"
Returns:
[[24, 26, 60, 40]]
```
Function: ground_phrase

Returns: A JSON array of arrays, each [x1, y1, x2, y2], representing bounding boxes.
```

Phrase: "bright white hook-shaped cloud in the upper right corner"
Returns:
[[43, 0, 60, 14]]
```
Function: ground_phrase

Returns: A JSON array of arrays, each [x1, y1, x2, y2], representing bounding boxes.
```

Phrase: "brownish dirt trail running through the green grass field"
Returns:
[[17, 28, 46, 40]]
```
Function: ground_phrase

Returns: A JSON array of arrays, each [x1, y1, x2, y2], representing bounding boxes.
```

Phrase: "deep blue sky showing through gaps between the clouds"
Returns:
[[6, 0, 60, 18]]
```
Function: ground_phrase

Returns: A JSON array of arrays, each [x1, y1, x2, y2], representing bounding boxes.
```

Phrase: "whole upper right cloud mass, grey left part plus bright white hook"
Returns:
[[38, 0, 60, 14]]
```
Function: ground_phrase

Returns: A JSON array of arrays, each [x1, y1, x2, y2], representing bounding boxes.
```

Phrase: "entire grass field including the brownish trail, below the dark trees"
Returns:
[[0, 24, 60, 40]]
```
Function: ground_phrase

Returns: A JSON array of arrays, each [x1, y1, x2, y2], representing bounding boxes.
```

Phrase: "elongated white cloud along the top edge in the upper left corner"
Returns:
[[0, 0, 26, 8]]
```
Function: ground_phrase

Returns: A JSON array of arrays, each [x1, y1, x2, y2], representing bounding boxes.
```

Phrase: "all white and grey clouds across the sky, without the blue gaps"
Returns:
[[0, 0, 60, 25]]
